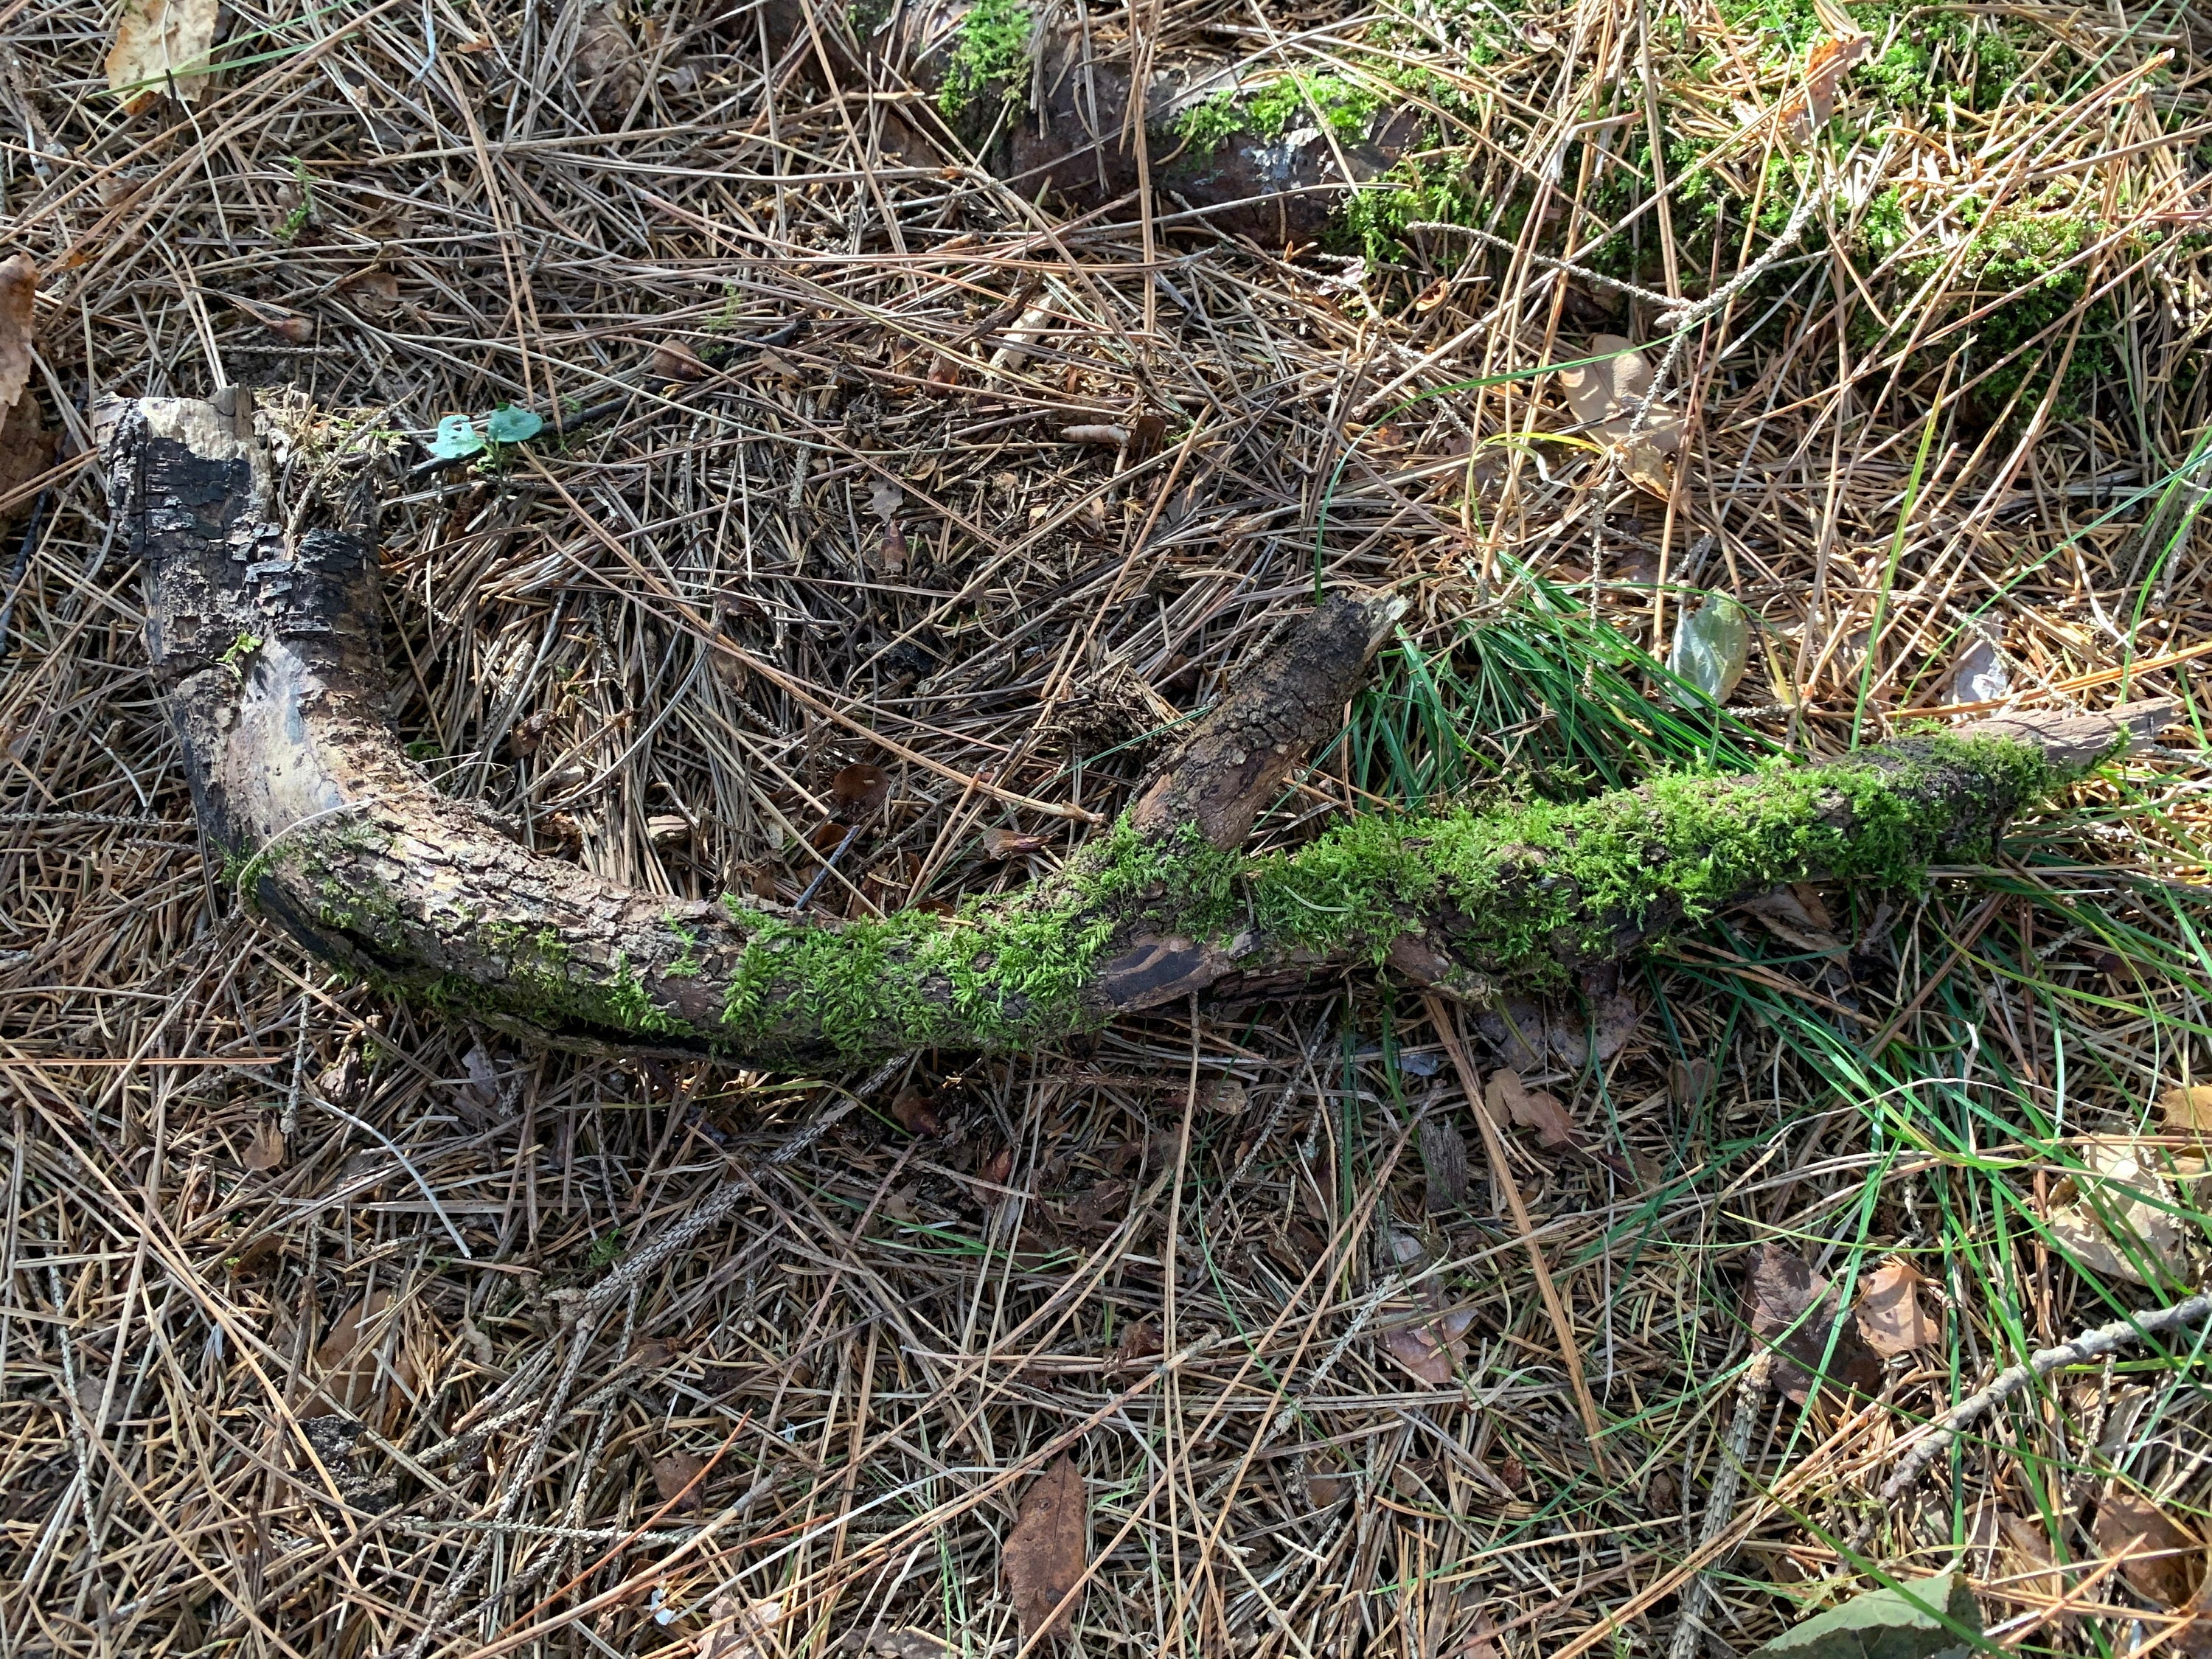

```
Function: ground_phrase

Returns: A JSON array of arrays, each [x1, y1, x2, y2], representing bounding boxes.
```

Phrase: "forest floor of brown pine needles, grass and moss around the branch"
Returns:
[[0, 0, 2212, 1659]]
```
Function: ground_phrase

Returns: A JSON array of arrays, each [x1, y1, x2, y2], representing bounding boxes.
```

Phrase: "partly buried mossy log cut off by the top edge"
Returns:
[[761, 0, 1429, 248]]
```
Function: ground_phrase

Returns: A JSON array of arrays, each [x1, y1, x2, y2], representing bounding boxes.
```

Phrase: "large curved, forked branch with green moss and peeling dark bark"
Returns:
[[100, 392, 2170, 1066]]
